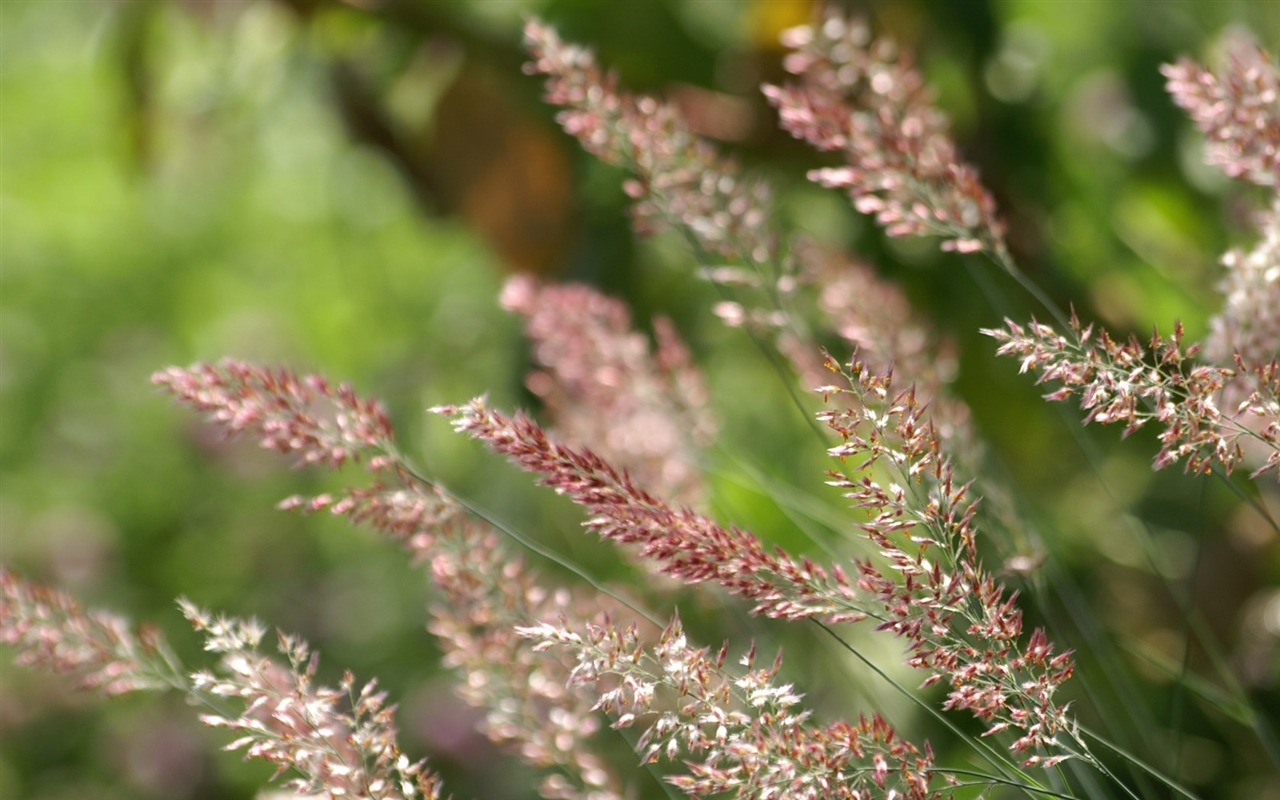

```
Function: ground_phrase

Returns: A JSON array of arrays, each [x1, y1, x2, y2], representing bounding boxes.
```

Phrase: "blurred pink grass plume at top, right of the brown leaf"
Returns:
[[764, 14, 1005, 255]]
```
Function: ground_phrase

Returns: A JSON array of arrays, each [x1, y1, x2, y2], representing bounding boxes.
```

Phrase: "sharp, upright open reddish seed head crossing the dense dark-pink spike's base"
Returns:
[[819, 361, 1085, 765]]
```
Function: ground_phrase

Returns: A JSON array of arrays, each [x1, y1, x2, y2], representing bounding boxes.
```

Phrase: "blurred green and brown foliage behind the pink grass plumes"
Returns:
[[0, 0, 1280, 800]]
